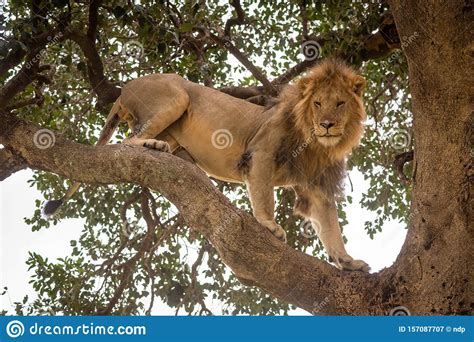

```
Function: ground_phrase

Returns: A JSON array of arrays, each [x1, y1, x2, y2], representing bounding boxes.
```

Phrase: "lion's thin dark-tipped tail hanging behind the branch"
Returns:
[[42, 97, 120, 217]]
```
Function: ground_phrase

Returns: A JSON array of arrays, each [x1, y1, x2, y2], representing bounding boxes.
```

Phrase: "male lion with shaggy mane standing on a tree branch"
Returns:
[[44, 60, 369, 272]]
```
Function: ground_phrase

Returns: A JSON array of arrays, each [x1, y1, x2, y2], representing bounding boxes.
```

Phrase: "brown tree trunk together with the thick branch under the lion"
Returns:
[[0, 0, 474, 315]]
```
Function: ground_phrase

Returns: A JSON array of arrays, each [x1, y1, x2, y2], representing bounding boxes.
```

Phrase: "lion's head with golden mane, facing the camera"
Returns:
[[282, 60, 366, 157]]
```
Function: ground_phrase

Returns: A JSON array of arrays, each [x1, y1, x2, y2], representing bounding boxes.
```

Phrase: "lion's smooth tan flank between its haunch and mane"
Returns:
[[161, 86, 268, 182]]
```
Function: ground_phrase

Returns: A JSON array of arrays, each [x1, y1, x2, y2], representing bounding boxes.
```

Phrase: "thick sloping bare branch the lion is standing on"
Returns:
[[0, 113, 391, 314]]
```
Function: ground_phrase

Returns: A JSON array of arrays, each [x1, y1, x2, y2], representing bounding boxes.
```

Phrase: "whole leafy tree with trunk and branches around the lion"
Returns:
[[0, 0, 474, 314]]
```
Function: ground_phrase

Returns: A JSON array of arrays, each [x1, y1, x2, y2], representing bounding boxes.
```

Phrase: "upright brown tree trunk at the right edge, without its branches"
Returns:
[[390, 0, 474, 314]]
